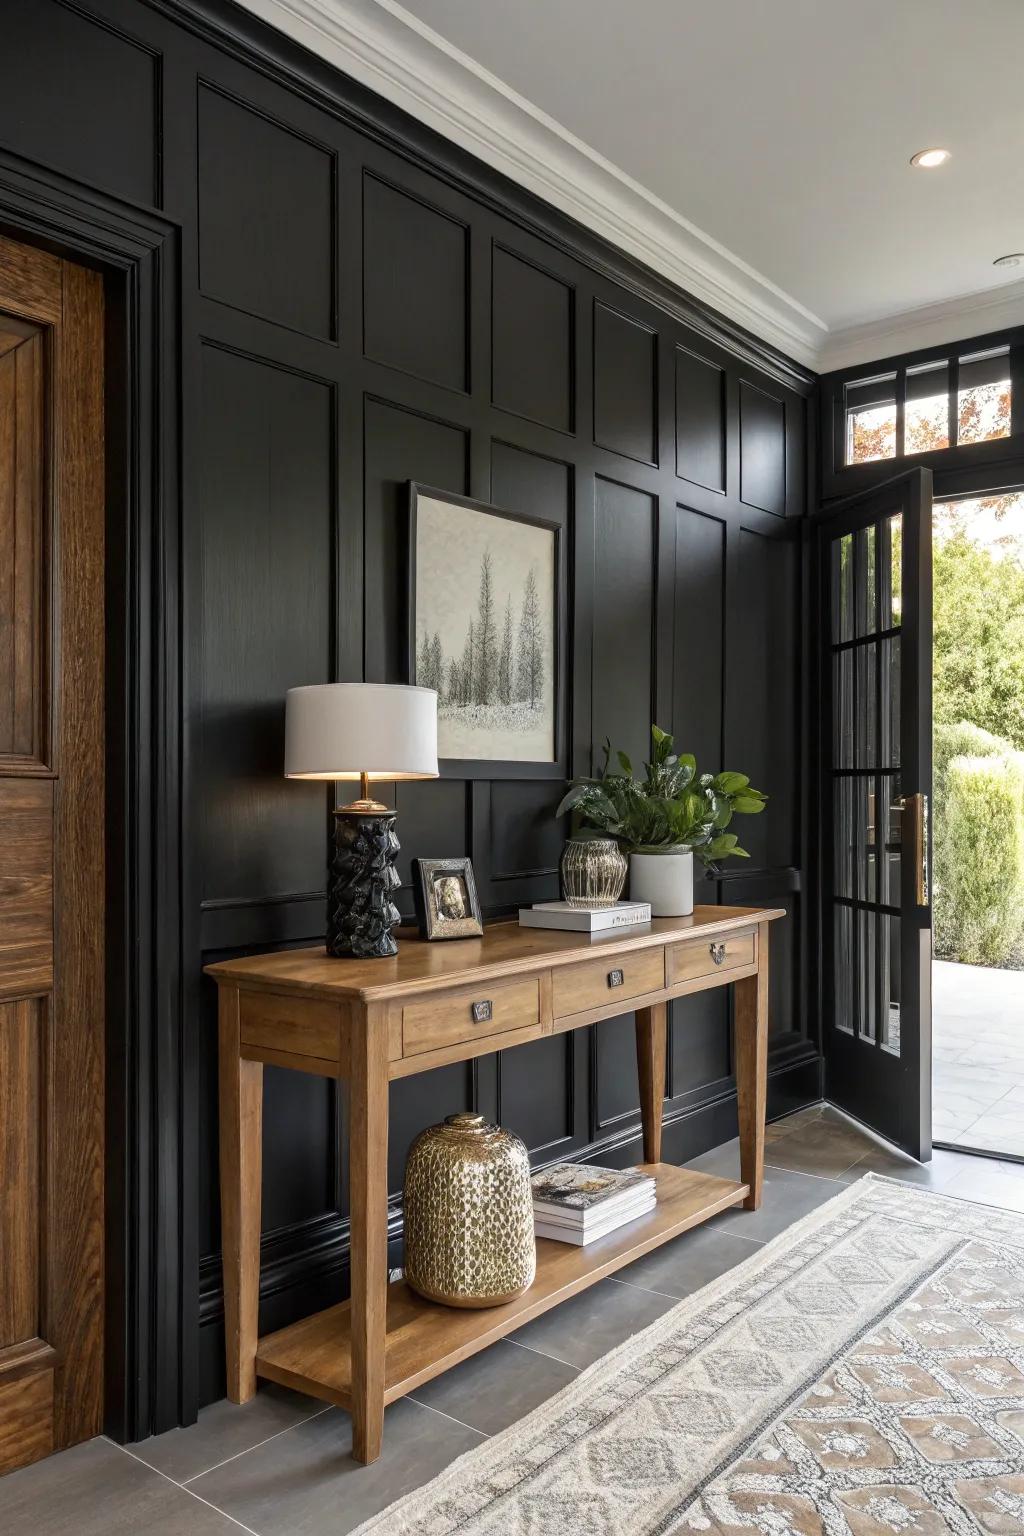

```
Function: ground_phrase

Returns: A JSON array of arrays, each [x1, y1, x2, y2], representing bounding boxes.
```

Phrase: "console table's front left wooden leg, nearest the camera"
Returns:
[[348, 1008, 387, 1462]]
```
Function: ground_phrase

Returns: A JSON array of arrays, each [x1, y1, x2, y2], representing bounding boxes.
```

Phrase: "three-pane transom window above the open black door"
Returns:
[[846, 347, 1010, 464]]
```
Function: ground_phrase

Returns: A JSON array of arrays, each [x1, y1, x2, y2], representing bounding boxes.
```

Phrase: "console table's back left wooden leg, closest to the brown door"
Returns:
[[220, 986, 263, 1402]]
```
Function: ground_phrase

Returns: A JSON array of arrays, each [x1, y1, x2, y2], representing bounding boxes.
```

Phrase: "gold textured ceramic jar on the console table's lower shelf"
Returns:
[[405, 1115, 537, 1307]]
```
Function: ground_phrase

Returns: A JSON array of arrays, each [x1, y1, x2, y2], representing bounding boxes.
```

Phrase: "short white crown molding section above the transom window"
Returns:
[[818, 281, 1024, 373]]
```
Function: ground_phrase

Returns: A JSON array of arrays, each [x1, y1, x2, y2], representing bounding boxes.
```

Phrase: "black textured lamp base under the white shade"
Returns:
[[327, 811, 399, 960]]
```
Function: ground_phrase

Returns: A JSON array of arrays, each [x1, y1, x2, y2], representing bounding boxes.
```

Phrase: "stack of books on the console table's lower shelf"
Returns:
[[531, 1163, 656, 1247]]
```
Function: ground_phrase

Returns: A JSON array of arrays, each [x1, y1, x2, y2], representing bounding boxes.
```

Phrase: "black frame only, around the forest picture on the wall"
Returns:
[[407, 481, 570, 779]]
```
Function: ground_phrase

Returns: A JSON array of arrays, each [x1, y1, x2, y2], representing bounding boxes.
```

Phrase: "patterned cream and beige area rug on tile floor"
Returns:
[[359, 1175, 1024, 1536]]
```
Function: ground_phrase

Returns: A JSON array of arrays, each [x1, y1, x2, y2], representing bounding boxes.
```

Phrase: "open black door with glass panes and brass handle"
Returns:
[[818, 468, 932, 1160]]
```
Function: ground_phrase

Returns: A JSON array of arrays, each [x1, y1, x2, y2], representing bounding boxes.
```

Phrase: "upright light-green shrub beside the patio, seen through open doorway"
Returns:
[[933, 752, 1024, 965]]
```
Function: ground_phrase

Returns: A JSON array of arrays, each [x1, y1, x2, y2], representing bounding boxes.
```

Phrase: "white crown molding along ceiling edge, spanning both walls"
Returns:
[[234, 0, 1024, 372]]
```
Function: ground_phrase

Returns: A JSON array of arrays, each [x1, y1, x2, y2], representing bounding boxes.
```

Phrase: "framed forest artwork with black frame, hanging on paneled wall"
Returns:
[[408, 484, 565, 779]]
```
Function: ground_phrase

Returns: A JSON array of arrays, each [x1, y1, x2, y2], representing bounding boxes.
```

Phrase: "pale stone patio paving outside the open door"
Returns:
[[932, 960, 1024, 1157]]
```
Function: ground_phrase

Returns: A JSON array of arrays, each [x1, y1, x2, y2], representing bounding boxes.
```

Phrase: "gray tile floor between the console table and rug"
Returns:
[[0, 1106, 1024, 1536]]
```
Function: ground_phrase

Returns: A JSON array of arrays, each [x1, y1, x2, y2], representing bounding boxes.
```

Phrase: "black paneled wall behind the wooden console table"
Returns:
[[0, 0, 814, 1416]]
